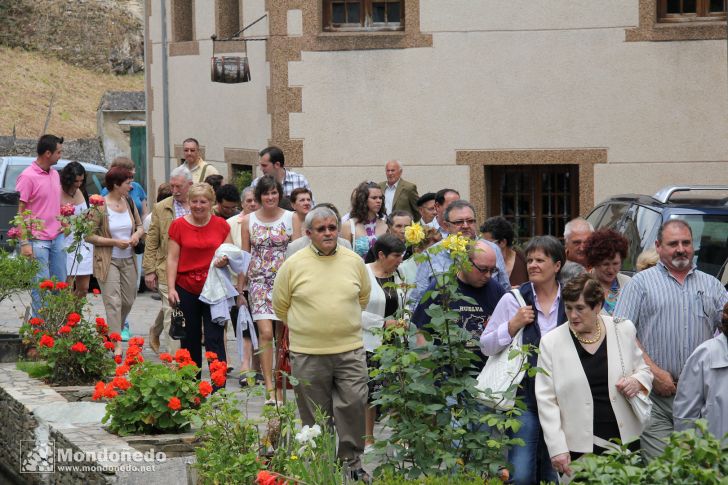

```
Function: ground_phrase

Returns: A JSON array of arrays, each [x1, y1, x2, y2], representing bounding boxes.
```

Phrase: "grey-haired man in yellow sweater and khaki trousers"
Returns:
[[273, 207, 371, 481]]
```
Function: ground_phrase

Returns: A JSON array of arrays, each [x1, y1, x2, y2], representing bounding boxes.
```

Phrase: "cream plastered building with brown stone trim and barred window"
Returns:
[[145, 0, 728, 240]]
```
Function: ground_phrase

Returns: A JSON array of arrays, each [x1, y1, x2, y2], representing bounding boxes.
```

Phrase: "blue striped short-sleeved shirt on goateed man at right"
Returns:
[[614, 261, 728, 380]]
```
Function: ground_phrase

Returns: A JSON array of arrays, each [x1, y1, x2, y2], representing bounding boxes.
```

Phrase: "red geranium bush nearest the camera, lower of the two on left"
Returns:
[[99, 346, 219, 436]]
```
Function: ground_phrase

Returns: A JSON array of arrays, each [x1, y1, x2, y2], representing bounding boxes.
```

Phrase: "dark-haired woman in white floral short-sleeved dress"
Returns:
[[240, 175, 301, 404]]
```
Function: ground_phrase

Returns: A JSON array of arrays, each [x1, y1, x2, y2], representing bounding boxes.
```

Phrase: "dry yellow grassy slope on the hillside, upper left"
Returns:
[[0, 46, 144, 139]]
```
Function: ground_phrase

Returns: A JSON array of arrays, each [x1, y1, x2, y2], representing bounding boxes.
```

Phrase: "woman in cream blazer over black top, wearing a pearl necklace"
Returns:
[[536, 274, 652, 475]]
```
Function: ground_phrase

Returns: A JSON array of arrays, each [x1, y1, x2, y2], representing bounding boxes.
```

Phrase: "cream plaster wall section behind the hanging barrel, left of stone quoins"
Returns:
[[147, 0, 270, 183]]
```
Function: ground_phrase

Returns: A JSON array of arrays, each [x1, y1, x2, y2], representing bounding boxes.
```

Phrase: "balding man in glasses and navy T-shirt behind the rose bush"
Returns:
[[412, 241, 505, 367]]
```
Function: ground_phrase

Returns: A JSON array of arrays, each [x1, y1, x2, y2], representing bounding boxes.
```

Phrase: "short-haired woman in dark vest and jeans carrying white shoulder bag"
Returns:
[[480, 236, 566, 484]]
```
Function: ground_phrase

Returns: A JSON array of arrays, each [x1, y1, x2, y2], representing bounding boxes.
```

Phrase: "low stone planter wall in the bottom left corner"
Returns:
[[0, 364, 196, 485]]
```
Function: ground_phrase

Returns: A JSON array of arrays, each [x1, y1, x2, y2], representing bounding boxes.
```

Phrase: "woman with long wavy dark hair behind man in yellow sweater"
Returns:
[[341, 182, 387, 259]]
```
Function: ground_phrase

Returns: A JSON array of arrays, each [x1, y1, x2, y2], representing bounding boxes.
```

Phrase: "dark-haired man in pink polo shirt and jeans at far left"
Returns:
[[15, 135, 67, 311]]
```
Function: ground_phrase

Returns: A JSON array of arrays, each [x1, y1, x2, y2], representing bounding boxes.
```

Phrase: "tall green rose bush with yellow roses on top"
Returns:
[[370, 228, 536, 480]]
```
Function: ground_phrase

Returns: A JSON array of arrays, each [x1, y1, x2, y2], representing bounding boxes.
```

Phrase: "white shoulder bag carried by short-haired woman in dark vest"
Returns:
[[475, 290, 527, 411]]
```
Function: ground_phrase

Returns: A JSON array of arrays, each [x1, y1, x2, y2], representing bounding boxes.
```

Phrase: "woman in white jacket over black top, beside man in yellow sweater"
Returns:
[[361, 234, 406, 451]]
